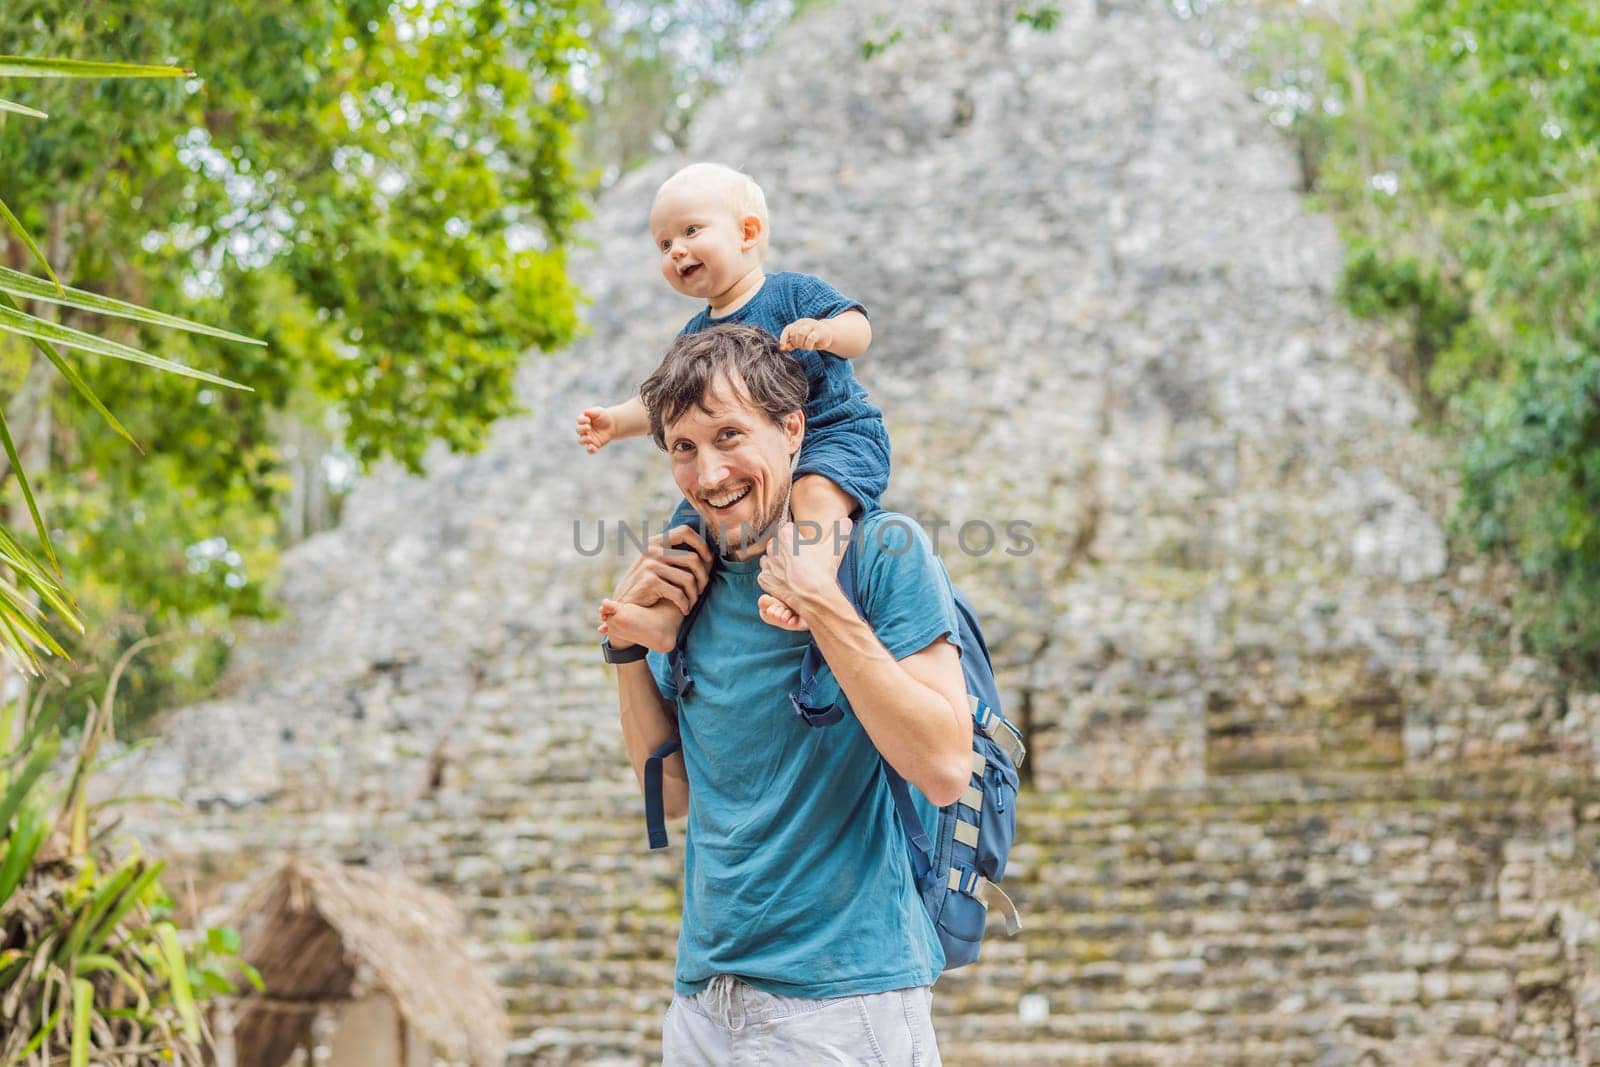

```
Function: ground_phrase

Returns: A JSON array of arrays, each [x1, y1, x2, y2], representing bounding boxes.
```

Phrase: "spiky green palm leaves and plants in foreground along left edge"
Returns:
[[0, 56, 259, 1067]]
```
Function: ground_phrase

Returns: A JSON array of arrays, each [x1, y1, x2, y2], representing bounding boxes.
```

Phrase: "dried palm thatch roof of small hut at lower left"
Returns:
[[232, 857, 509, 1067]]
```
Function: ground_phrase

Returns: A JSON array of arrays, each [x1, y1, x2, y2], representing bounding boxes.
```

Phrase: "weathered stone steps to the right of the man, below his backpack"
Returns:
[[939, 776, 1594, 1064]]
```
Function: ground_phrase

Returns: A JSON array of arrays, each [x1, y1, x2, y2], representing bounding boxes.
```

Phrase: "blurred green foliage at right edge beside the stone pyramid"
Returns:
[[1259, 0, 1600, 675]]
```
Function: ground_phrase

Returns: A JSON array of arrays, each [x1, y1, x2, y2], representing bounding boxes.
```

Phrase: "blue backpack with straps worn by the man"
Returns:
[[645, 524, 1027, 969]]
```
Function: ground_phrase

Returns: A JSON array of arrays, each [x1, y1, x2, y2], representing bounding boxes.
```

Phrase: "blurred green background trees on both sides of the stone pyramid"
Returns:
[[0, 0, 1600, 735]]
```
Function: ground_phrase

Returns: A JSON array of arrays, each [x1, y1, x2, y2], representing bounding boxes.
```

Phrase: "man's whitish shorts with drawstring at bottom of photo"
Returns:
[[661, 974, 941, 1067]]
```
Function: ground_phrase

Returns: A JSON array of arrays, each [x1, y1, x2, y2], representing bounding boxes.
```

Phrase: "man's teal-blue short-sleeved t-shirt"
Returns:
[[650, 512, 958, 998]]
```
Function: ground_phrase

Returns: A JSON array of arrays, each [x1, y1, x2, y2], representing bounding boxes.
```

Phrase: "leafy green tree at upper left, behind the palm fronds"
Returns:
[[0, 0, 600, 726]]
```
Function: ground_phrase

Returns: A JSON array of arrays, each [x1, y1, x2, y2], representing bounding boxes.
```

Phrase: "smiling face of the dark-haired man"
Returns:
[[666, 371, 805, 560]]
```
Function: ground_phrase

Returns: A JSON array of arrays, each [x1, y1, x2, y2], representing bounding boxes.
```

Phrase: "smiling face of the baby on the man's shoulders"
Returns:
[[650, 182, 760, 304]]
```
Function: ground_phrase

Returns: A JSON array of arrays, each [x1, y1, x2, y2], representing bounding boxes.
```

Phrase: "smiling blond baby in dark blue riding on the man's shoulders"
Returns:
[[578, 163, 890, 651]]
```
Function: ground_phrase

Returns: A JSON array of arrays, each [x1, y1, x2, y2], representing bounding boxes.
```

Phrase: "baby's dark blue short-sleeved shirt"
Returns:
[[680, 270, 883, 430]]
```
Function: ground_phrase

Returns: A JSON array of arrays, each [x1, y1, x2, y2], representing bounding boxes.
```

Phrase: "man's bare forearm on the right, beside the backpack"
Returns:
[[802, 590, 971, 805]]
